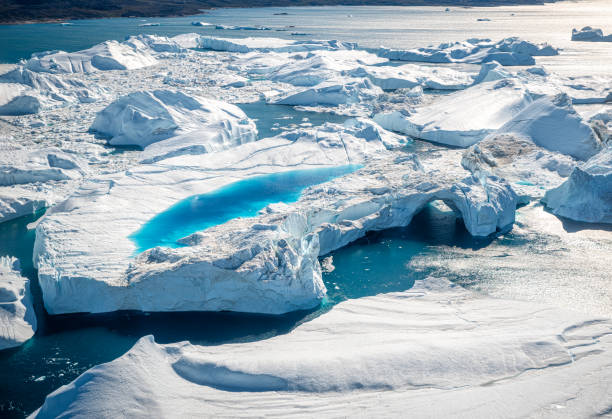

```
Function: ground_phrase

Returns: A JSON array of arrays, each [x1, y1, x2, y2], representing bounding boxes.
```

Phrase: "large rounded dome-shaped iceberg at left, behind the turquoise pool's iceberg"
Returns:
[[91, 90, 256, 148]]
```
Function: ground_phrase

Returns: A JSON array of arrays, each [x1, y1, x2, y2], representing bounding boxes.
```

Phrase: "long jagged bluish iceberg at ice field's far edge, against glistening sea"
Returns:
[[378, 37, 559, 66]]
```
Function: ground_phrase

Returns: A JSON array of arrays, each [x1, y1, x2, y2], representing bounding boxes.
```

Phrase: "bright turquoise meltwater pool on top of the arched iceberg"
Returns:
[[130, 165, 362, 253]]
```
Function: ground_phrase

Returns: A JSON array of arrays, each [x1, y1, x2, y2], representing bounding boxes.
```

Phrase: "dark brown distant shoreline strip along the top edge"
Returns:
[[0, 0, 557, 25]]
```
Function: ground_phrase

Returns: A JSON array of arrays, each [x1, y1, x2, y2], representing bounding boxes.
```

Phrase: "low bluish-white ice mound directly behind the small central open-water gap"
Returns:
[[272, 78, 383, 106]]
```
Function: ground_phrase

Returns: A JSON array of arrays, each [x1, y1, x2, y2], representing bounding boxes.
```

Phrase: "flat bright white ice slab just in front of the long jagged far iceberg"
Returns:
[[349, 64, 474, 90]]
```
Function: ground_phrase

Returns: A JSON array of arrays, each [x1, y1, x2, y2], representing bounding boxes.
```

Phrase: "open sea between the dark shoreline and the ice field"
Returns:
[[0, 0, 612, 75]]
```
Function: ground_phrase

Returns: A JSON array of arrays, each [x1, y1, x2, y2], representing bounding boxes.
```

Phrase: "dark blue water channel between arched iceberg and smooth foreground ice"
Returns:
[[0, 203, 498, 417]]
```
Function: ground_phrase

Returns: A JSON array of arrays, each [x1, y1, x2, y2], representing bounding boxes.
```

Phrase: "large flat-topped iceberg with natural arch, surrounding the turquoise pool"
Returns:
[[35, 127, 517, 314]]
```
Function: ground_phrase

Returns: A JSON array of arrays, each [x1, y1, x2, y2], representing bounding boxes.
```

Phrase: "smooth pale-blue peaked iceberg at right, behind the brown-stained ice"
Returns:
[[499, 94, 602, 160]]
